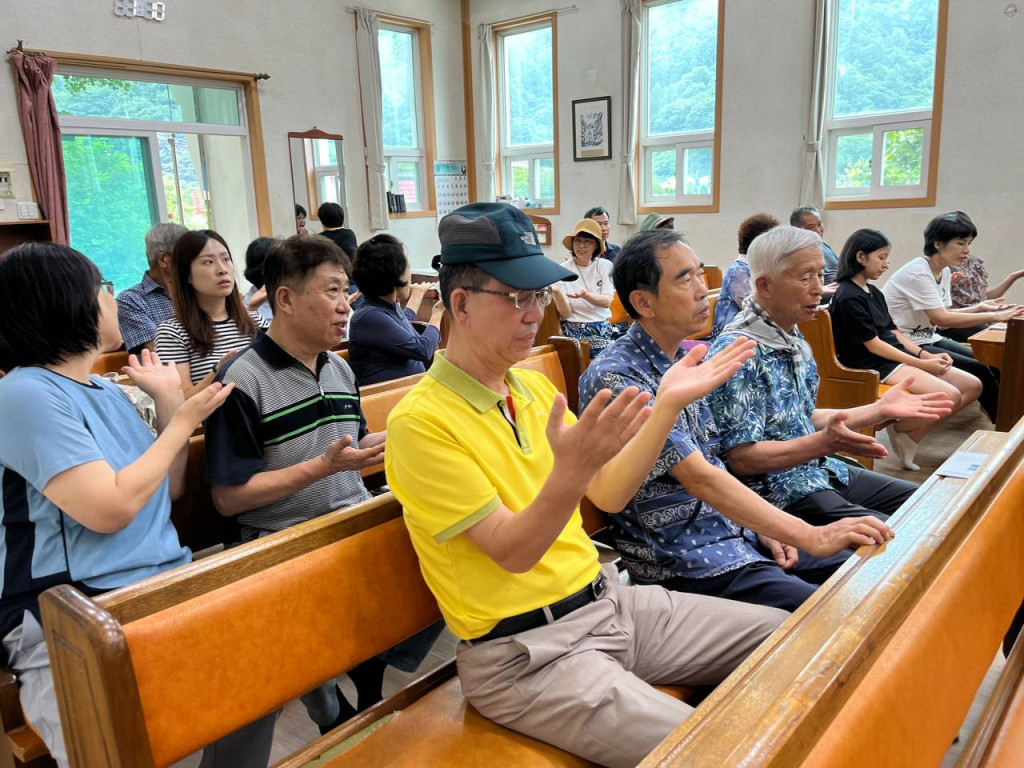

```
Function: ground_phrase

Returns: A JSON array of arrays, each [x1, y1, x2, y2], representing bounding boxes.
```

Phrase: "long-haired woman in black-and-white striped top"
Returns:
[[157, 229, 270, 398]]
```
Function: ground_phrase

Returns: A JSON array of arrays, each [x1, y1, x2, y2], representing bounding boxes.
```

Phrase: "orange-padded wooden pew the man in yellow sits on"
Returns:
[[41, 494, 685, 768]]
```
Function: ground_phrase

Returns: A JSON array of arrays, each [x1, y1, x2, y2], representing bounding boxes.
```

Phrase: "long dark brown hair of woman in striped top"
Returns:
[[171, 229, 257, 355]]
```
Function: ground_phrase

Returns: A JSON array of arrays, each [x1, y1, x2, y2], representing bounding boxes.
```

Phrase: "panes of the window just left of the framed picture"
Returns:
[[498, 22, 557, 208]]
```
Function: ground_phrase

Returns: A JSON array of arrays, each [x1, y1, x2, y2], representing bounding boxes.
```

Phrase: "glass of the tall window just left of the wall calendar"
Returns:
[[377, 24, 429, 211]]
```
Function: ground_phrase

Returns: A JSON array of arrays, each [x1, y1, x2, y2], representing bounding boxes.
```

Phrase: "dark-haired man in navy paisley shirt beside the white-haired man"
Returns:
[[580, 229, 892, 610]]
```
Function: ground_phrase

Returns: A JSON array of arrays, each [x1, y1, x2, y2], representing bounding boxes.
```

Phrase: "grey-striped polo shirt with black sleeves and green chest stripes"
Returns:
[[205, 334, 370, 541]]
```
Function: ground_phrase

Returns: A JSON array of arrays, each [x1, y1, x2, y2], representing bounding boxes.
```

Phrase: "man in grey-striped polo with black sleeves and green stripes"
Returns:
[[206, 236, 391, 732]]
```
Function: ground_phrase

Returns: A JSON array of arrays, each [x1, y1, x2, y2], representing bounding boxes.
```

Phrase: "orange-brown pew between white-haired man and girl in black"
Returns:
[[800, 308, 890, 469]]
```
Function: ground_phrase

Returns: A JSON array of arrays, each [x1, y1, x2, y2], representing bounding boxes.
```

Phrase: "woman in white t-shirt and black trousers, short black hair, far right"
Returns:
[[882, 212, 1021, 423]]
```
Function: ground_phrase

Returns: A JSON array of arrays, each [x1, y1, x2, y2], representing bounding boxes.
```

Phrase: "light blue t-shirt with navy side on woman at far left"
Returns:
[[0, 368, 191, 651]]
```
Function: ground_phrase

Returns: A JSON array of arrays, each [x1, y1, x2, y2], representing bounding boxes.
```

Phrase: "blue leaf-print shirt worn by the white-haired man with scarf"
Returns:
[[708, 329, 849, 508]]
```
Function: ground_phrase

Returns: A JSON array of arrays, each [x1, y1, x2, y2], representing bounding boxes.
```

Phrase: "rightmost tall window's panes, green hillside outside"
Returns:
[[826, 0, 941, 200]]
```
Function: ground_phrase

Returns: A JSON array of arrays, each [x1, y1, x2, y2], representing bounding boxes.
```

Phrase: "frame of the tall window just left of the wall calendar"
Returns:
[[378, 13, 437, 219]]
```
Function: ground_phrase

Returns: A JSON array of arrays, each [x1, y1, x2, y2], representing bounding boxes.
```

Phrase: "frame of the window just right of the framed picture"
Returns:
[[635, 0, 726, 214]]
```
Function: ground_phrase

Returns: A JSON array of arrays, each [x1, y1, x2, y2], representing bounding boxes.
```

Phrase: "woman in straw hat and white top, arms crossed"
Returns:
[[552, 219, 615, 357]]
